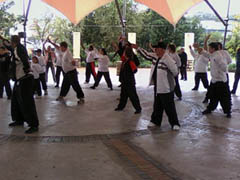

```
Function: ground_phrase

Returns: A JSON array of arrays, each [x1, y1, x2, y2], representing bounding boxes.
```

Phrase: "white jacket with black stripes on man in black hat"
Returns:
[[138, 48, 178, 94]]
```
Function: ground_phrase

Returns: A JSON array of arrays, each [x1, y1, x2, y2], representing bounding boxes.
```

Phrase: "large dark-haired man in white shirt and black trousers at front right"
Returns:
[[195, 43, 231, 118]]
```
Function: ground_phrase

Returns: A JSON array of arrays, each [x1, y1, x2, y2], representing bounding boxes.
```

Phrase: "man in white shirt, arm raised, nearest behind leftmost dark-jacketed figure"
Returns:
[[56, 42, 84, 104]]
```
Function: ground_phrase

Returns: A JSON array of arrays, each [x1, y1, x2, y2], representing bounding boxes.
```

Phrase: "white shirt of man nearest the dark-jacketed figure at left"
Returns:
[[62, 49, 76, 73]]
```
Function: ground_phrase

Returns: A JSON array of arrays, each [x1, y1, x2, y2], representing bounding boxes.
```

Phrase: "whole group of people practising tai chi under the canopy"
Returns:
[[0, 32, 240, 133]]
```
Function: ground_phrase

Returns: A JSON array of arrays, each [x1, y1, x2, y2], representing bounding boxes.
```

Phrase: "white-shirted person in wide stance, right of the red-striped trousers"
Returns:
[[90, 48, 113, 90]]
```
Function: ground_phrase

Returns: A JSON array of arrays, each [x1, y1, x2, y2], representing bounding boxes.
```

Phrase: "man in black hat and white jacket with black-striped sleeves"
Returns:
[[132, 42, 180, 130]]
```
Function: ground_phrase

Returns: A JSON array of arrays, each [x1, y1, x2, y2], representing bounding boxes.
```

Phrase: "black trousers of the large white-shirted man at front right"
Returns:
[[207, 82, 231, 114]]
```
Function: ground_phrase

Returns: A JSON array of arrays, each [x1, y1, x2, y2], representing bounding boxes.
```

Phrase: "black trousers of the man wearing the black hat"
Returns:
[[151, 92, 180, 127]]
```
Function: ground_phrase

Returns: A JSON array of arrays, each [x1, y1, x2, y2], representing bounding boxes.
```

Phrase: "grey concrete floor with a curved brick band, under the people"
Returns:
[[0, 69, 240, 180]]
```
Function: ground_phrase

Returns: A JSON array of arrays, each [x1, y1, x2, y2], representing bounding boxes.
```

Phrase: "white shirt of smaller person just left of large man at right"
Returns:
[[190, 49, 209, 73]]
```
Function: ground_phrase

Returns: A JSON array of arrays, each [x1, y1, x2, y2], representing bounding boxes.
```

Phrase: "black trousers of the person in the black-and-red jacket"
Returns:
[[118, 83, 142, 111]]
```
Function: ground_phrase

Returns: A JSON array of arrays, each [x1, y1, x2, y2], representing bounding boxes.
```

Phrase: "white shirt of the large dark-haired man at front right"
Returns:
[[202, 51, 227, 83]]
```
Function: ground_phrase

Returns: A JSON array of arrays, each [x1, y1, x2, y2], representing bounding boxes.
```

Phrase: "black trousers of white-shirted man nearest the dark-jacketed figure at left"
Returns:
[[60, 69, 84, 99]]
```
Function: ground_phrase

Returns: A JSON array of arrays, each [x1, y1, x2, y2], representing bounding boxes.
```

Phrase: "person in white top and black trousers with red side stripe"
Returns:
[[81, 42, 97, 84]]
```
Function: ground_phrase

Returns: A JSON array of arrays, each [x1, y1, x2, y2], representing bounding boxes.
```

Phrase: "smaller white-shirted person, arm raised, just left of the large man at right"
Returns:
[[189, 46, 209, 91]]
